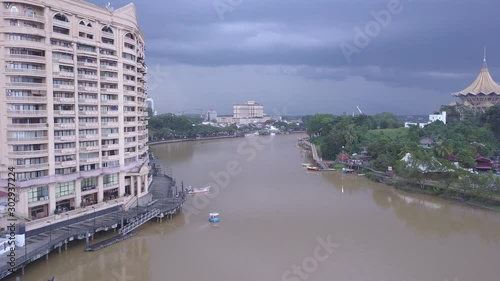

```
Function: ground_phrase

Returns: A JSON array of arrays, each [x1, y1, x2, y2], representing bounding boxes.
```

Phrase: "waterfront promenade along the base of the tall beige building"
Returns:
[[0, 160, 186, 279]]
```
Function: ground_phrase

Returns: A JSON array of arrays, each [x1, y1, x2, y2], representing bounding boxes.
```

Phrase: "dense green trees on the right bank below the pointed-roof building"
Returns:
[[307, 106, 500, 201]]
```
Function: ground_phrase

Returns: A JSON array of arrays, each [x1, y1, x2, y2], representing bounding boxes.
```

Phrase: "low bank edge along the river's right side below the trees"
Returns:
[[299, 139, 500, 211]]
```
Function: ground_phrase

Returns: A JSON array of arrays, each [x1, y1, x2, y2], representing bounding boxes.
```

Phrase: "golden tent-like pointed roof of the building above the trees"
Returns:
[[453, 54, 500, 112]]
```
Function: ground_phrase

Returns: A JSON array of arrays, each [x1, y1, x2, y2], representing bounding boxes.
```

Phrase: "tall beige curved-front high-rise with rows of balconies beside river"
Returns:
[[0, 0, 151, 219]]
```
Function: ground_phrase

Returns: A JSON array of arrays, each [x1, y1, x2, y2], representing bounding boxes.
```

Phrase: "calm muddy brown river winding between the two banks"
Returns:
[[7, 135, 500, 281]]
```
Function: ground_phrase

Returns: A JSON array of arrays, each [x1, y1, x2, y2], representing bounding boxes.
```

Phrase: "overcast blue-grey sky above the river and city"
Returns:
[[91, 0, 500, 114]]
